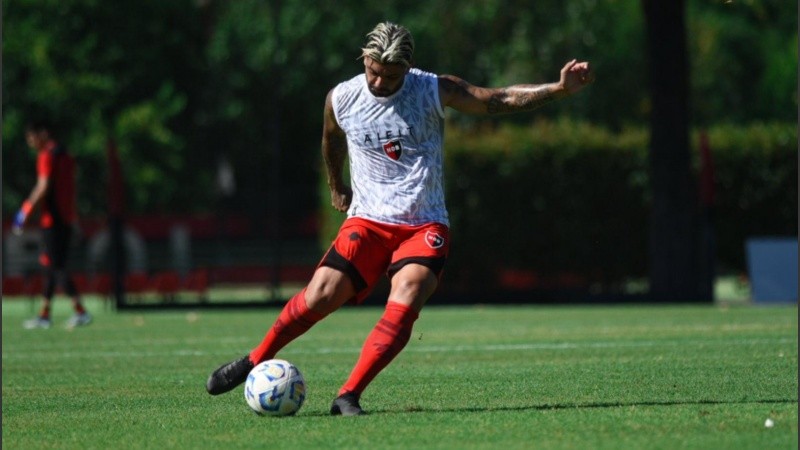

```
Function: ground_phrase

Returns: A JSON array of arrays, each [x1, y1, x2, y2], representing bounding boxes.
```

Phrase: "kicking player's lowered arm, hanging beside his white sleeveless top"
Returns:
[[322, 90, 353, 212]]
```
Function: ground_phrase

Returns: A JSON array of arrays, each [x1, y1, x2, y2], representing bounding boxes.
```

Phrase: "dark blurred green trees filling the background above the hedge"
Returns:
[[2, 0, 797, 229]]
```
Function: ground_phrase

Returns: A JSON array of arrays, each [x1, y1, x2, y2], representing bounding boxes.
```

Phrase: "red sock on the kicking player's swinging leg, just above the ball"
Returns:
[[250, 289, 325, 364]]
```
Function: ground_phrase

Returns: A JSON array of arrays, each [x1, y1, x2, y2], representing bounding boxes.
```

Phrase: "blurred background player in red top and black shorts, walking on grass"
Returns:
[[13, 121, 92, 329]]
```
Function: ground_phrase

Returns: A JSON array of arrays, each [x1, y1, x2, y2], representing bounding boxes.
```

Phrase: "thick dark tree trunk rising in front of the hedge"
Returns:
[[642, 0, 699, 302]]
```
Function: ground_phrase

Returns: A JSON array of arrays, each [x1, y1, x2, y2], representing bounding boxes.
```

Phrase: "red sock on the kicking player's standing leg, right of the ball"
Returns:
[[339, 300, 419, 396]]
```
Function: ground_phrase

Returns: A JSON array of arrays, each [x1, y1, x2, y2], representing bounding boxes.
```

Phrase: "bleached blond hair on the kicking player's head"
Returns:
[[361, 22, 414, 67]]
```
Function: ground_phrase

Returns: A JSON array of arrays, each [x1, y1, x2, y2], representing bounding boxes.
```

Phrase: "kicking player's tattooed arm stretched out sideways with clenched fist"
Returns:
[[439, 60, 594, 114]]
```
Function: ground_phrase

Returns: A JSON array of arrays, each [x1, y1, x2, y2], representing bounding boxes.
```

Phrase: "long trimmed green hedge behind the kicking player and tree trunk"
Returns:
[[321, 120, 797, 290]]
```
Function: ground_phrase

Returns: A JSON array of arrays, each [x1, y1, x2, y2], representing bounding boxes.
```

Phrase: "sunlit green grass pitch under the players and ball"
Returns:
[[2, 300, 798, 449]]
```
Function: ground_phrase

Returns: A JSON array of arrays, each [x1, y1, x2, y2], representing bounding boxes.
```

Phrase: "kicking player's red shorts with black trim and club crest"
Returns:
[[319, 217, 450, 302]]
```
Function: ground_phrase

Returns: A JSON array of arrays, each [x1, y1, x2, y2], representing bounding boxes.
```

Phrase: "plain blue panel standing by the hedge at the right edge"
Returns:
[[746, 237, 797, 303]]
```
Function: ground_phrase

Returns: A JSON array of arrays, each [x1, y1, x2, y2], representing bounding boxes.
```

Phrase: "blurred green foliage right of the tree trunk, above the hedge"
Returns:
[[687, 0, 798, 125]]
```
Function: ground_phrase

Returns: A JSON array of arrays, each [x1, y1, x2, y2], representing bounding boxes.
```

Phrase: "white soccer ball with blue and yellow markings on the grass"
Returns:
[[244, 359, 306, 416]]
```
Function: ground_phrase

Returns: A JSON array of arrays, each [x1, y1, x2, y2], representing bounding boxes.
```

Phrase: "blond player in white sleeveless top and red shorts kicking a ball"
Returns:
[[206, 22, 593, 416]]
